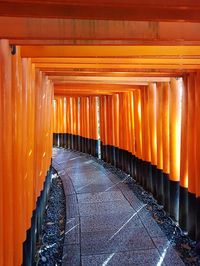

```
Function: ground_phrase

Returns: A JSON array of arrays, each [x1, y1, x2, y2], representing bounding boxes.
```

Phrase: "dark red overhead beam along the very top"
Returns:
[[0, 0, 200, 21]]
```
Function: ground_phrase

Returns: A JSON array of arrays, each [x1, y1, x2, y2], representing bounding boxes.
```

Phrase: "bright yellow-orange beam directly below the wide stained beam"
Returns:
[[21, 45, 200, 58]]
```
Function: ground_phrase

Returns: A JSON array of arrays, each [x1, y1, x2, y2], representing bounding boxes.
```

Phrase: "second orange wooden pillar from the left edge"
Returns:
[[11, 44, 23, 265]]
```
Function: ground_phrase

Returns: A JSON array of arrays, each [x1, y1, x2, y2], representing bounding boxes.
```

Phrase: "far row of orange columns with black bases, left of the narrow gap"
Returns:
[[53, 95, 98, 157]]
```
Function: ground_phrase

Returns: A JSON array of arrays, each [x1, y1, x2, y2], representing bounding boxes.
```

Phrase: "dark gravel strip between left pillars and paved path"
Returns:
[[35, 169, 66, 266]]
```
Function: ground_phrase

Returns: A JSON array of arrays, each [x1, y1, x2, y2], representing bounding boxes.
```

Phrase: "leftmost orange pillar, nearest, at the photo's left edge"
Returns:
[[0, 40, 14, 265]]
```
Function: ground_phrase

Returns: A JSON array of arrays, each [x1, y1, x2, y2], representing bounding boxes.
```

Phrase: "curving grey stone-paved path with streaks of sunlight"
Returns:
[[53, 149, 184, 266]]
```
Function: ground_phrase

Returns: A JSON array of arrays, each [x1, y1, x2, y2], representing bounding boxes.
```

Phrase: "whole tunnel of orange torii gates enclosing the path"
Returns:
[[0, 0, 200, 266]]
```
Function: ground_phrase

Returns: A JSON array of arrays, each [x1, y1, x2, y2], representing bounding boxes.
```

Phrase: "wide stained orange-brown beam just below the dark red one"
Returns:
[[0, 17, 200, 45]]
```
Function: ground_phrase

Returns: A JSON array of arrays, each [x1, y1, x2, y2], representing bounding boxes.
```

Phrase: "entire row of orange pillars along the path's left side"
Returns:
[[0, 40, 53, 265]]
